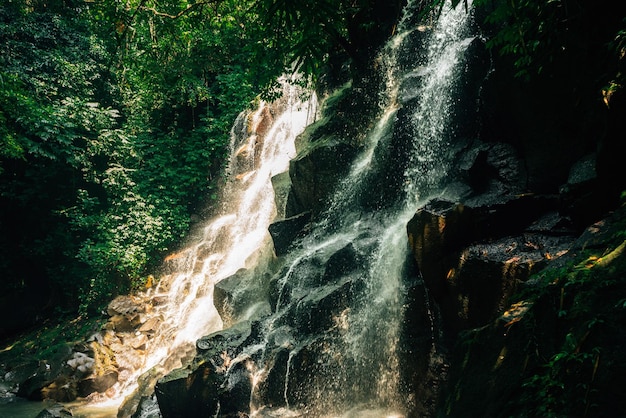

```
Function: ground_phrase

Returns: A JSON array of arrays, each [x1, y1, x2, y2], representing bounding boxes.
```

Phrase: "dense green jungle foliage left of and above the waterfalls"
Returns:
[[0, 0, 626, 336]]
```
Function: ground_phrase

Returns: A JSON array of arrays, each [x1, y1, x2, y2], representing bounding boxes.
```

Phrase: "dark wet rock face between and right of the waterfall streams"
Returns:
[[156, 1, 623, 418]]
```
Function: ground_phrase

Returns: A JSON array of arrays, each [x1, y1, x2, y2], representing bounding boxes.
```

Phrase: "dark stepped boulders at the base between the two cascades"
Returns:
[[155, 244, 370, 418]]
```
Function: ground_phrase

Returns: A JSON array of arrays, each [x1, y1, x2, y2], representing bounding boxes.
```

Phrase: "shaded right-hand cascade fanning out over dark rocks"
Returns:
[[161, 1, 472, 417]]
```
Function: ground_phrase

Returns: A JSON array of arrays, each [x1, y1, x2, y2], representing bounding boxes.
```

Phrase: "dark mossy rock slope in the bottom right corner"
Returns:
[[440, 207, 626, 417]]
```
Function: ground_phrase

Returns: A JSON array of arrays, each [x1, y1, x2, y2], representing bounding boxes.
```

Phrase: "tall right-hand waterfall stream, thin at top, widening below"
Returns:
[[230, 2, 470, 418]]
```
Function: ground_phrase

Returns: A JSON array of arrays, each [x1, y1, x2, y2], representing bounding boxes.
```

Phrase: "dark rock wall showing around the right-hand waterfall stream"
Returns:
[[152, 1, 626, 417]]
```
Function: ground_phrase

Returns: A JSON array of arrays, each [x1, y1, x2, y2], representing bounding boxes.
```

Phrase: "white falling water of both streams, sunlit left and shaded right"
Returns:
[[75, 1, 472, 417]]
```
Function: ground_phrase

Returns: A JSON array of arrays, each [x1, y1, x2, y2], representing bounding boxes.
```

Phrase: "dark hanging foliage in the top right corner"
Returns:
[[470, 0, 626, 87]]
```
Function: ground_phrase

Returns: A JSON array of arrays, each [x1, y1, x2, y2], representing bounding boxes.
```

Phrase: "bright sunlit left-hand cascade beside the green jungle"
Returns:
[[74, 83, 317, 417]]
